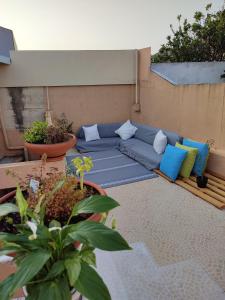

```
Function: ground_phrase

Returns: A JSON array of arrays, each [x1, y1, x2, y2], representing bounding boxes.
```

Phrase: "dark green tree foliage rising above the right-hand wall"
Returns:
[[152, 4, 225, 63]]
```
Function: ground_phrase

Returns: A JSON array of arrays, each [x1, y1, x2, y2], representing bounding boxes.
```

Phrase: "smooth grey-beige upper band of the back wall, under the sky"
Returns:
[[0, 50, 136, 87]]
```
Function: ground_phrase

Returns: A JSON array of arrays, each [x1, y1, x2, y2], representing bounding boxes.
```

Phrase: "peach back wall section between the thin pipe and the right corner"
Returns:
[[49, 85, 134, 130]]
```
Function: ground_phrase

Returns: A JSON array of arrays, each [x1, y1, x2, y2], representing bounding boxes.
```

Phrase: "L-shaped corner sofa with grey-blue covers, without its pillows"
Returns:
[[76, 122, 182, 170]]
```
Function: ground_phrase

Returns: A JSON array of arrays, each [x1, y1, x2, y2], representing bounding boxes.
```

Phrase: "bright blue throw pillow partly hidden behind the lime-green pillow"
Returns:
[[183, 139, 209, 176]]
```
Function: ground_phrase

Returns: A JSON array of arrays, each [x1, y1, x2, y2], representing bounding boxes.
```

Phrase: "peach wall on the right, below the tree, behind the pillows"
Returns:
[[132, 48, 225, 175]]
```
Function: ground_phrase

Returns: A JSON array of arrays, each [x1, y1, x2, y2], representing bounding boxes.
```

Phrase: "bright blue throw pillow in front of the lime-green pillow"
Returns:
[[160, 145, 188, 181]]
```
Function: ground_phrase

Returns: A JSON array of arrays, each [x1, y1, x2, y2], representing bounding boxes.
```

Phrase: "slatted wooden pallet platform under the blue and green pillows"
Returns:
[[155, 170, 225, 209]]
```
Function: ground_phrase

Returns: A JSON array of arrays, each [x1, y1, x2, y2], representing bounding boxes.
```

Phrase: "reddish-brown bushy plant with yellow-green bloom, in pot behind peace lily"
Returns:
[[0, 155, 106, 233]]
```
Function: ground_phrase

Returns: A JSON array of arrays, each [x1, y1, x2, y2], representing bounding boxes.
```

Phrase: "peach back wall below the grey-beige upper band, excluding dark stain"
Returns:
[[0, 85, 134, 156]]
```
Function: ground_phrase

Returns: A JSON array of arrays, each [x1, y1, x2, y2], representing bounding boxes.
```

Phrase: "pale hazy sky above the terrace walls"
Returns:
[[0, 0, 223, 53]]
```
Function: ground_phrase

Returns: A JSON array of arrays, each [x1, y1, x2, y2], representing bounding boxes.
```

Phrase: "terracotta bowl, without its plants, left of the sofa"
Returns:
[[24, 133, 77, 161]]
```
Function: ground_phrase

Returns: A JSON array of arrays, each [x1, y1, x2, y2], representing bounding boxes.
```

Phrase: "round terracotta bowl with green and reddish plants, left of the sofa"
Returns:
[[24, 119, 76, 161]]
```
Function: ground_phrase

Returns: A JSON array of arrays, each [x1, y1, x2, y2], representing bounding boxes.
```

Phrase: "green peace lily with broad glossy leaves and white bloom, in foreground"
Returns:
[[0, 187, 131, 300]]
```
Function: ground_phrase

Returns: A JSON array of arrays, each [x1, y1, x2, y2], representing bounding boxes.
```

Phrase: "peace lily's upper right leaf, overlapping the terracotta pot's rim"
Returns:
[[72, 195, 119, 216]]
